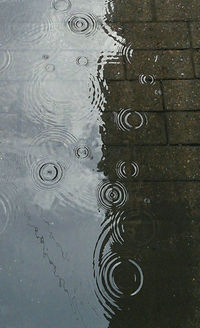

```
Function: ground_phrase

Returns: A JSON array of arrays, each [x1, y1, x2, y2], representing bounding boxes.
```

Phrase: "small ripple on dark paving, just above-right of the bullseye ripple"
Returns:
[[116, 161, 139, 179]]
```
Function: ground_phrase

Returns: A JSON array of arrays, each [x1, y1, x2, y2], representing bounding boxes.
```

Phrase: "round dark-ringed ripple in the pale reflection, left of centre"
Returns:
[[31, 159, 63, 189]]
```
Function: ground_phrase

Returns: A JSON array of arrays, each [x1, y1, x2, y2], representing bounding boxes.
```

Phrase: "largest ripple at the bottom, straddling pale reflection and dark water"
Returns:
[[94, 251, 144, 315]]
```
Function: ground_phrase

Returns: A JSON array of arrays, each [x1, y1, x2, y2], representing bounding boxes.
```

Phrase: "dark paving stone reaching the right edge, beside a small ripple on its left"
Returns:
[[132, 146, 200, 180]]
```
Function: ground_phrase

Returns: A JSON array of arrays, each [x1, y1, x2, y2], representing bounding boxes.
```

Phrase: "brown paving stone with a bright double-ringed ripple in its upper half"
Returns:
[[100, 111, 166, 145]]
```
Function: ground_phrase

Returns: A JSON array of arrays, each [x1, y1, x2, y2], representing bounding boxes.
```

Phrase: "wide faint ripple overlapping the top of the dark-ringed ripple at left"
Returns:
[[26, 128, 77, 169]]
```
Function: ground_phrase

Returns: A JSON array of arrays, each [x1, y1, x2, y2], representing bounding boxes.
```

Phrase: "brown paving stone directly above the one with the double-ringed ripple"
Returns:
[[106, 81, 163, 111]]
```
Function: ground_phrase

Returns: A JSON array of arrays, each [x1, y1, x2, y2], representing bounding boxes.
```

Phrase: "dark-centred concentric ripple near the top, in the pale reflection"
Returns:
[[65, 13, 98, 37]]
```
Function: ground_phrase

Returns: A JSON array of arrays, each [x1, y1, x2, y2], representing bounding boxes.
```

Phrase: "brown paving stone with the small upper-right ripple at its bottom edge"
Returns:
[[127, 50, 194, 79]]
